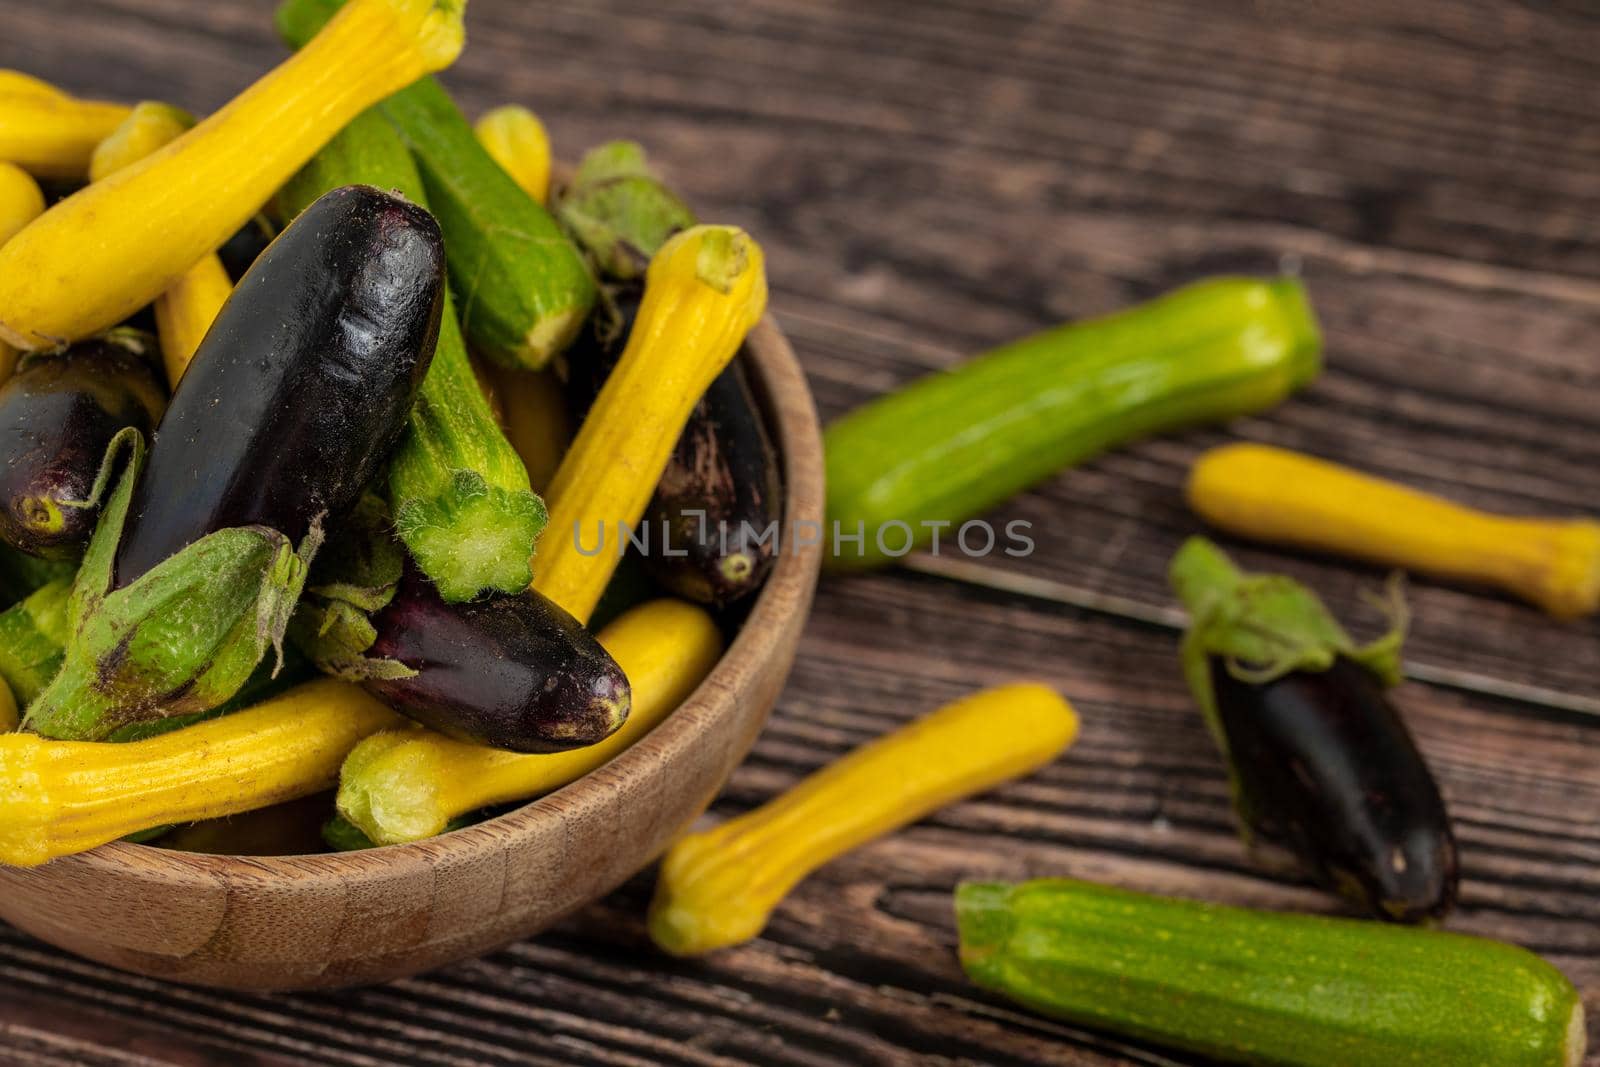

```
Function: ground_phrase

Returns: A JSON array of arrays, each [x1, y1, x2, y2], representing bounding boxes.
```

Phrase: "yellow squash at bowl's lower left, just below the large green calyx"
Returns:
[[0, 678, 405, 867]]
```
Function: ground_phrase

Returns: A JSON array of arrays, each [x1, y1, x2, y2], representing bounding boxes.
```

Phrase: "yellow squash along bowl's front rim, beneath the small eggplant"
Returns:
[[338, 600, 722, 845]]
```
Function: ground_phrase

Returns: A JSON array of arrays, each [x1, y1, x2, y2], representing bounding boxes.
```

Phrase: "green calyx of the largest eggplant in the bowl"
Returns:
[[24, 429, 322, 741]]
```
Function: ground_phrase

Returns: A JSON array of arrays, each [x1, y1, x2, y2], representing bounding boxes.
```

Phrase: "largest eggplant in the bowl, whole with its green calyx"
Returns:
[[26, 186, 445, 741]]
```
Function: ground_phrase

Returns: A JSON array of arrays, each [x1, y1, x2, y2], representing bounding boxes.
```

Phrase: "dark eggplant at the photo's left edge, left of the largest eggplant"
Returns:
[[0, 331, 166, 560]]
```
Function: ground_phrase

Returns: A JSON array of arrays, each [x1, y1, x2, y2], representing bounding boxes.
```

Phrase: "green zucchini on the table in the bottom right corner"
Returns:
[[955, 878, 1584, 1067]]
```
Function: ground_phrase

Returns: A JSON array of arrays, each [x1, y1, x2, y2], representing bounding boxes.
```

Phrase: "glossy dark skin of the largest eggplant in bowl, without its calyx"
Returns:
[[114, 186, 445, 589]]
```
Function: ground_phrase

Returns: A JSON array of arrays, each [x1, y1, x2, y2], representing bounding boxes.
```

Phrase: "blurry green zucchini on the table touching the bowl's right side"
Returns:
[[824, 278, 1322, 569]]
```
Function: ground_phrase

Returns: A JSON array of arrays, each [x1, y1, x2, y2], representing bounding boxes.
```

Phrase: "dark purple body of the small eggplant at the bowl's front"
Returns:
[[362, 563, 632, 752]]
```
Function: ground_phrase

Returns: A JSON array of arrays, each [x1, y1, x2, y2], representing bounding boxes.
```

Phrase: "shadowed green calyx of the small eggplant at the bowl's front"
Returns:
[[290, 493, 416, 681]]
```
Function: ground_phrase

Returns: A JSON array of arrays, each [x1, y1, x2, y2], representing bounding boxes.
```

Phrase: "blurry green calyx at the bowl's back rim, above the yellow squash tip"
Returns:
[[555, 141, 694, 282]]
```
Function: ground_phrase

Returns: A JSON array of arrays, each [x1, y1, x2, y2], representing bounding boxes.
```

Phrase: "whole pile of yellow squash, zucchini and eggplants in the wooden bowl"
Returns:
[[0, 0, 781, 865]]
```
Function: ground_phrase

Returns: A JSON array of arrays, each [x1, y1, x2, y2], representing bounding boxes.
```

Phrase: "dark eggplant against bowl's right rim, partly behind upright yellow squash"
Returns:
[[568, 286, 782, 608]]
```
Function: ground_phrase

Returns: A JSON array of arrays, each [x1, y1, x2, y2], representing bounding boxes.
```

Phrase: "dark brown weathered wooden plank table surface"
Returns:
[[0, 0, 1600, 1064]]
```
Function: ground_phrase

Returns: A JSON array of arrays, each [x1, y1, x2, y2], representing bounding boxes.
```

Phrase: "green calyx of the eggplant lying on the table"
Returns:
[[1168, 537, 1406, 750]]
